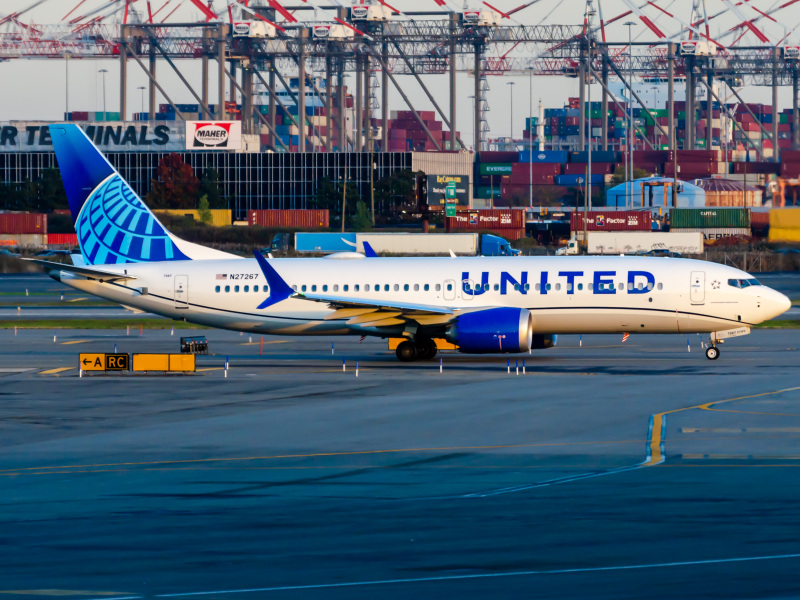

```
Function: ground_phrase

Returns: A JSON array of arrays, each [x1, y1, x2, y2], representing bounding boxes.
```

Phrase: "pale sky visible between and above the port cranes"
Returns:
[[0, 0, 800, 141]]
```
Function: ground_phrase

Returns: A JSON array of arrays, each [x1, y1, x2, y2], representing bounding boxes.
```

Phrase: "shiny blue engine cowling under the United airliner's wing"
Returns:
[[445, 308, 533, 354]]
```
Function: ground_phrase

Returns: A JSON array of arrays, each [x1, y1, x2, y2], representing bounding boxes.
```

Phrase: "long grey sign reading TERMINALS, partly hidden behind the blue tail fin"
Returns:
[[0, 121, 184, 152]]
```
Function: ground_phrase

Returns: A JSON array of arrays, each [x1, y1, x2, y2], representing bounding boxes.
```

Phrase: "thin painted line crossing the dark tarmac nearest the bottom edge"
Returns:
[[141, 554, 800, 600]]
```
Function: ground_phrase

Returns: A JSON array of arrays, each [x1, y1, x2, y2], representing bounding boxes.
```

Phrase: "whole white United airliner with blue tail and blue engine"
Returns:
[[29, 125, 791, 361]]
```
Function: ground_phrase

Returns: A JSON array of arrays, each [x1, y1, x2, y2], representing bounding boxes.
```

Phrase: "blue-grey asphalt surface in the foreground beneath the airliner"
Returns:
[[0, 316, 800, 600]]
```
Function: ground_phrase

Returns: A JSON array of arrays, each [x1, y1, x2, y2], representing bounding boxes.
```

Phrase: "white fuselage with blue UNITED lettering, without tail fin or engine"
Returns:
[[54, 256, 786, 337]]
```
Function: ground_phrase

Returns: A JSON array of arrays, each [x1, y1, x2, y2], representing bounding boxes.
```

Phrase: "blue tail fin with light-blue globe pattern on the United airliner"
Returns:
[[50, 125, 192, 265]]
